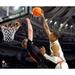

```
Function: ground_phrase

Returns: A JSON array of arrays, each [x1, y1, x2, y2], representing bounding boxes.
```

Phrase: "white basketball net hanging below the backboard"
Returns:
[[1, 26, 18, 42]]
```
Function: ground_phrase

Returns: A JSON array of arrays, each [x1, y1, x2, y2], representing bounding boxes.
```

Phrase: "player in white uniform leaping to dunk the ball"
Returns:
[[40, 14, 68, 69]]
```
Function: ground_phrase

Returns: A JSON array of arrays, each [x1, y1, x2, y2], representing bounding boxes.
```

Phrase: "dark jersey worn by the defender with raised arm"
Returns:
[[27, 40, 48, 68]]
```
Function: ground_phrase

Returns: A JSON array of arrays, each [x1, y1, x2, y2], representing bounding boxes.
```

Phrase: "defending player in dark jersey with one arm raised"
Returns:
[[22, 18, 47, 68]]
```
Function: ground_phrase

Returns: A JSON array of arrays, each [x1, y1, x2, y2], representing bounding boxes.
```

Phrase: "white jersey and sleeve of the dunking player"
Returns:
[[44, 40, 68, 69]]
